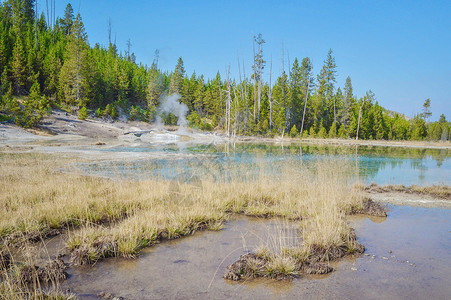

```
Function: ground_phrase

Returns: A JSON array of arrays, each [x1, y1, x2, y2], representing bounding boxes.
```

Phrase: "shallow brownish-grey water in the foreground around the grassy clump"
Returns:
[[63, 207, 451, 299]]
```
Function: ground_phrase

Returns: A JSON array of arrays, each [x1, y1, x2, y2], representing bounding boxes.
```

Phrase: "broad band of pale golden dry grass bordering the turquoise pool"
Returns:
[[0, 155, 363, 266]]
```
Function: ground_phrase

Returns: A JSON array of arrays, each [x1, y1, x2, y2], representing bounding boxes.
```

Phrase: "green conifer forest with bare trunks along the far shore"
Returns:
[[0, 0, 451, 140]]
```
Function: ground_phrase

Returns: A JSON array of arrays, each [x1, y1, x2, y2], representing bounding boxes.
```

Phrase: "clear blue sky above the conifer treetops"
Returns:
[[38, 0, 451, 120]]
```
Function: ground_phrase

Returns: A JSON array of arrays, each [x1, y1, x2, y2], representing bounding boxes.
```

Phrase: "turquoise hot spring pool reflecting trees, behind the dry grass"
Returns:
[[79, 143, 451, 185]]
